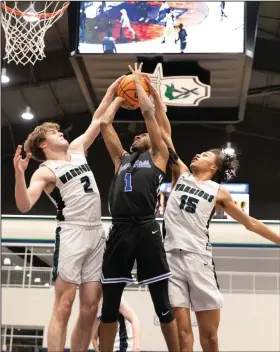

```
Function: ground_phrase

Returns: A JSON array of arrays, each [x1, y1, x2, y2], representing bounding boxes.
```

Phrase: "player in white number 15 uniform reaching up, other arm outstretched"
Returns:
[[144, 80, 280, 352]]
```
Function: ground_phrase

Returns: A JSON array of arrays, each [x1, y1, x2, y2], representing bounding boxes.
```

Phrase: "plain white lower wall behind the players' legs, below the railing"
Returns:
[[2, 288, 280, 351]]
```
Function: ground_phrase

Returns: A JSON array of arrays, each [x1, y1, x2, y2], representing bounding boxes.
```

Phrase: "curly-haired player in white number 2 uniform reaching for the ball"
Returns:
[[14, 78, 121, 351]]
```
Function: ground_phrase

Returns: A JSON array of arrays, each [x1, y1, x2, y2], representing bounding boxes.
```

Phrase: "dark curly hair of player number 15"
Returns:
[[209, 149, 239, 183]]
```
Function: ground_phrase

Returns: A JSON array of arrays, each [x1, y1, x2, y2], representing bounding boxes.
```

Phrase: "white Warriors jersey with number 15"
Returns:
[[164, 172, 219, 256]]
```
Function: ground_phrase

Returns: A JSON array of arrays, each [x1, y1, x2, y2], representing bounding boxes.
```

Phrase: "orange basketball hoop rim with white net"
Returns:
[[1, 1, 70, 65]]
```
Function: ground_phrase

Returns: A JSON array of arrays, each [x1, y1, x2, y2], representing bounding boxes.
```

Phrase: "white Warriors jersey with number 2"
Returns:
[[40, 152, 101, 226]]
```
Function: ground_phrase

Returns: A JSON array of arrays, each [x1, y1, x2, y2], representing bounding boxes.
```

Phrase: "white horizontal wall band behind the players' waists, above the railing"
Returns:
[[2, 216, 280, 244]]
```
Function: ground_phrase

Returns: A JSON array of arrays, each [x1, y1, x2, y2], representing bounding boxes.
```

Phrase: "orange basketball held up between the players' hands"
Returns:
[[117, 75, 150, 108]]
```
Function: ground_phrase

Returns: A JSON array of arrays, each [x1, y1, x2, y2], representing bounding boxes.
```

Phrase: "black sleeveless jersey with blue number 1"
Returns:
[[109, 152, 165, 218]]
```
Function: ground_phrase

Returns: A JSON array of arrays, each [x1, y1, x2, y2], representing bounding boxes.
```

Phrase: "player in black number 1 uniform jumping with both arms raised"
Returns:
[[100, 65, 179, 352]]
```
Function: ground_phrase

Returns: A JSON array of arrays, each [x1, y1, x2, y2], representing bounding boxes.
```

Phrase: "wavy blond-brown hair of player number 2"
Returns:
[[23, 122, 60, 161]]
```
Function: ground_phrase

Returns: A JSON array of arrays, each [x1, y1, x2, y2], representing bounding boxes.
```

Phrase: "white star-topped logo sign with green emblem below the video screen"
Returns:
[[144, 63, 211, 106]]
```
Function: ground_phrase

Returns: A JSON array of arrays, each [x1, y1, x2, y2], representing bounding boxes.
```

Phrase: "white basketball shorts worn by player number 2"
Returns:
[[53, 224, 106, 285]]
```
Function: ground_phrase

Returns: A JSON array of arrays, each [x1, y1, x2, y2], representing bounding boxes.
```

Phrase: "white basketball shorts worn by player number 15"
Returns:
[[166, 249, 223, 312]]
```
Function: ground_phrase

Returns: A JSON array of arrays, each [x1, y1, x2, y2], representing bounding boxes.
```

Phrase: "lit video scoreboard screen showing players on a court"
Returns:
[[78, 1, 245, 54]]
